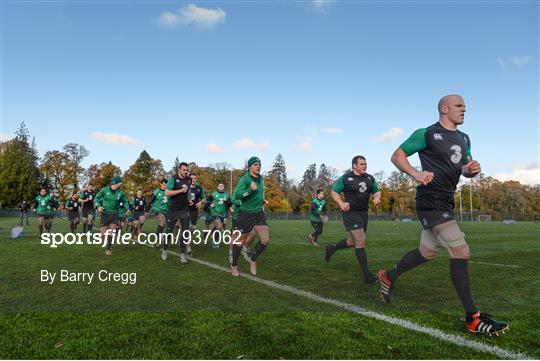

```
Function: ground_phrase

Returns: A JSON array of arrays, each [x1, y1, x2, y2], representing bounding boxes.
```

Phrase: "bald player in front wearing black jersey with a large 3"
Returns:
[[379, 95, 508, 335]]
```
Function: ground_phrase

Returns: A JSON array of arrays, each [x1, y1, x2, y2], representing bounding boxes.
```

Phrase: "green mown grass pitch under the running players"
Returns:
[[0, 218, 540, 359]]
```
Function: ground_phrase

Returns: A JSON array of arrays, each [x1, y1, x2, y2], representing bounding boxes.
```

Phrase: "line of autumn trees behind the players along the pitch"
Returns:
[[0, 123, 540, 220]]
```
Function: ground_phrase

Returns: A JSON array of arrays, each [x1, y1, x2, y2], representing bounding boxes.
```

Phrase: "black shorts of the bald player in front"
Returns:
[[416, 193, 456, 230]]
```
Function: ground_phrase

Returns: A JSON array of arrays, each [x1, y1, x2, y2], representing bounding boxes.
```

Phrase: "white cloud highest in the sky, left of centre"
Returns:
[[158, 4, 227, 29]]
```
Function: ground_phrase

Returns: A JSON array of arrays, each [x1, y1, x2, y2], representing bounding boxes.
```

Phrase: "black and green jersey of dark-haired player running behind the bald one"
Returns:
[[332, 171, 379, 212]]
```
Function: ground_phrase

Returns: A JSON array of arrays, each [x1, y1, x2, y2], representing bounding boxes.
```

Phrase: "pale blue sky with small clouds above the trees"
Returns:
[[1, 0, 540, 183]]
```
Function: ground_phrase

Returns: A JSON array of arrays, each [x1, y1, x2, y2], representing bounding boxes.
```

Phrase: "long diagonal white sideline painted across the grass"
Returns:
[[147, 245, 533, 360]]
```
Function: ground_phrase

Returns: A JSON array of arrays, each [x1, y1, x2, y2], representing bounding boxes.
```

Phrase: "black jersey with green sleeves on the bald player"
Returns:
[[400, 122, 472, 198]]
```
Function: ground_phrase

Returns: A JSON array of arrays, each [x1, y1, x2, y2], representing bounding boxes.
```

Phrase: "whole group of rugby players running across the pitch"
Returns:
[[30, 95, 509, 335]]
